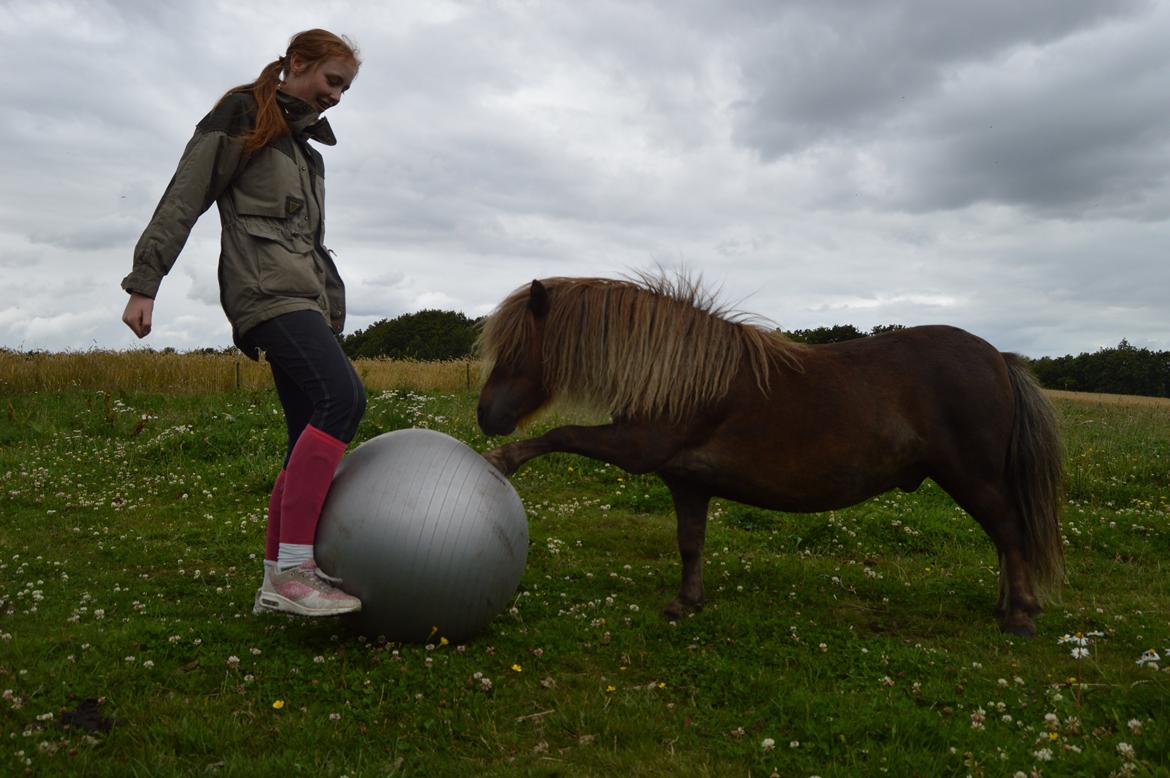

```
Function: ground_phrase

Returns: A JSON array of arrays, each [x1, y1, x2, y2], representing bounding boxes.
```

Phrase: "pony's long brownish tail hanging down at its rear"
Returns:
[[1004, 353, 1065, 600]]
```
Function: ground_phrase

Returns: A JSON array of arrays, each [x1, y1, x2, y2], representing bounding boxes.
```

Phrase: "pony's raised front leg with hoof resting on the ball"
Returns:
[[483, 421, 682, 476]]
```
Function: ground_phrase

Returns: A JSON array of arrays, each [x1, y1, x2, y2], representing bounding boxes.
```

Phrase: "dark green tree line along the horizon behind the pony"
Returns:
[[342, 310, 1170, 397]]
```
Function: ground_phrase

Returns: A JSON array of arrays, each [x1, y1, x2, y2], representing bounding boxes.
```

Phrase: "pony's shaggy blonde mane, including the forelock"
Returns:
[[477, 275, 803, 420]]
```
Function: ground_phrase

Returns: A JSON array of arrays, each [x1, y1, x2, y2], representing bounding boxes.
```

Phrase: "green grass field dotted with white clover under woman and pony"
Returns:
[[0, 390, 1170, 778]]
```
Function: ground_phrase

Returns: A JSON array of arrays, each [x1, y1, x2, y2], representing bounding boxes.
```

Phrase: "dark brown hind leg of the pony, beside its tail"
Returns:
[[941, 483, 1041, 635]]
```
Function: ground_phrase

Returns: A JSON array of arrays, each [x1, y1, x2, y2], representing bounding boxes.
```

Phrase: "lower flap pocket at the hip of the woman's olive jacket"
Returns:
[[239, 215, 324, 298]]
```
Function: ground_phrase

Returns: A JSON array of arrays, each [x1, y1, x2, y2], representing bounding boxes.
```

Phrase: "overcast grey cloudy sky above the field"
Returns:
[[0, 0, 1170, 357]]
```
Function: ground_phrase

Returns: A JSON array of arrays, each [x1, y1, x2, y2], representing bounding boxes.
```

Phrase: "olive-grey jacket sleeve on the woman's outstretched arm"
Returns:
[[122, 95, 254, 298]]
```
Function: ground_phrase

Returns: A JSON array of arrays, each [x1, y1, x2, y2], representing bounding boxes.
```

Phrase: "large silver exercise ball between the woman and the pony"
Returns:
[[315, 429, 528, 642]]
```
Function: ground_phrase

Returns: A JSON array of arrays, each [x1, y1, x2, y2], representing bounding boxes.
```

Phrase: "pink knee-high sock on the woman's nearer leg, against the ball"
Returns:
[[280, 425, 345, 546]]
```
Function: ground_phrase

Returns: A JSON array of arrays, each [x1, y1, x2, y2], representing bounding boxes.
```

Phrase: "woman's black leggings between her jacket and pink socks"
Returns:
[[241, 310, 366, 467]]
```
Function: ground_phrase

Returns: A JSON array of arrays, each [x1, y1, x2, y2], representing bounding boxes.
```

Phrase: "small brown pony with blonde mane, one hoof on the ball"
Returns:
[[477, 277, 1064, 635]]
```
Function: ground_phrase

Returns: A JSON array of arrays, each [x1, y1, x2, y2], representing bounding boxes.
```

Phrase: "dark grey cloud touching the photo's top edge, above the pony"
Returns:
[[737, 0, 1144, 158]]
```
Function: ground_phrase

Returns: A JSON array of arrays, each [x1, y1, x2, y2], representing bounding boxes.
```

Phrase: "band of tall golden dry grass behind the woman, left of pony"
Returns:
[[0, 350, 480, 394]]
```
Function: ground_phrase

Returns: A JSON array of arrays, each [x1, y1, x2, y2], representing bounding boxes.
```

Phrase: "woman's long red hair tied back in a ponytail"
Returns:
[[220, 29, 362, 152]]
